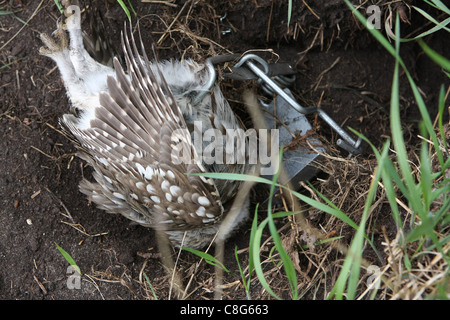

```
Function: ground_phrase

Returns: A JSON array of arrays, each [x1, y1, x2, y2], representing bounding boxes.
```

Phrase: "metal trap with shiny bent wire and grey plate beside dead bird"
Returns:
[[197, 54, 361, 189]]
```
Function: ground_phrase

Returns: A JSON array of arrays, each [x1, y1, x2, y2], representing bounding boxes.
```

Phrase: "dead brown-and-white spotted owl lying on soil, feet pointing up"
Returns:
[[40, 4, 251, 248]]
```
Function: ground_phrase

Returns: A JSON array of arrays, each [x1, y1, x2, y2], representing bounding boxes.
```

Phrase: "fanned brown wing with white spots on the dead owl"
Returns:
[[64, 29, 223, 230]]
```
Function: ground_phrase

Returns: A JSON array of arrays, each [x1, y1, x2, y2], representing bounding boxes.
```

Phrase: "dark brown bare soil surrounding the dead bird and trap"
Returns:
[[0, 0, 450, 299]]
